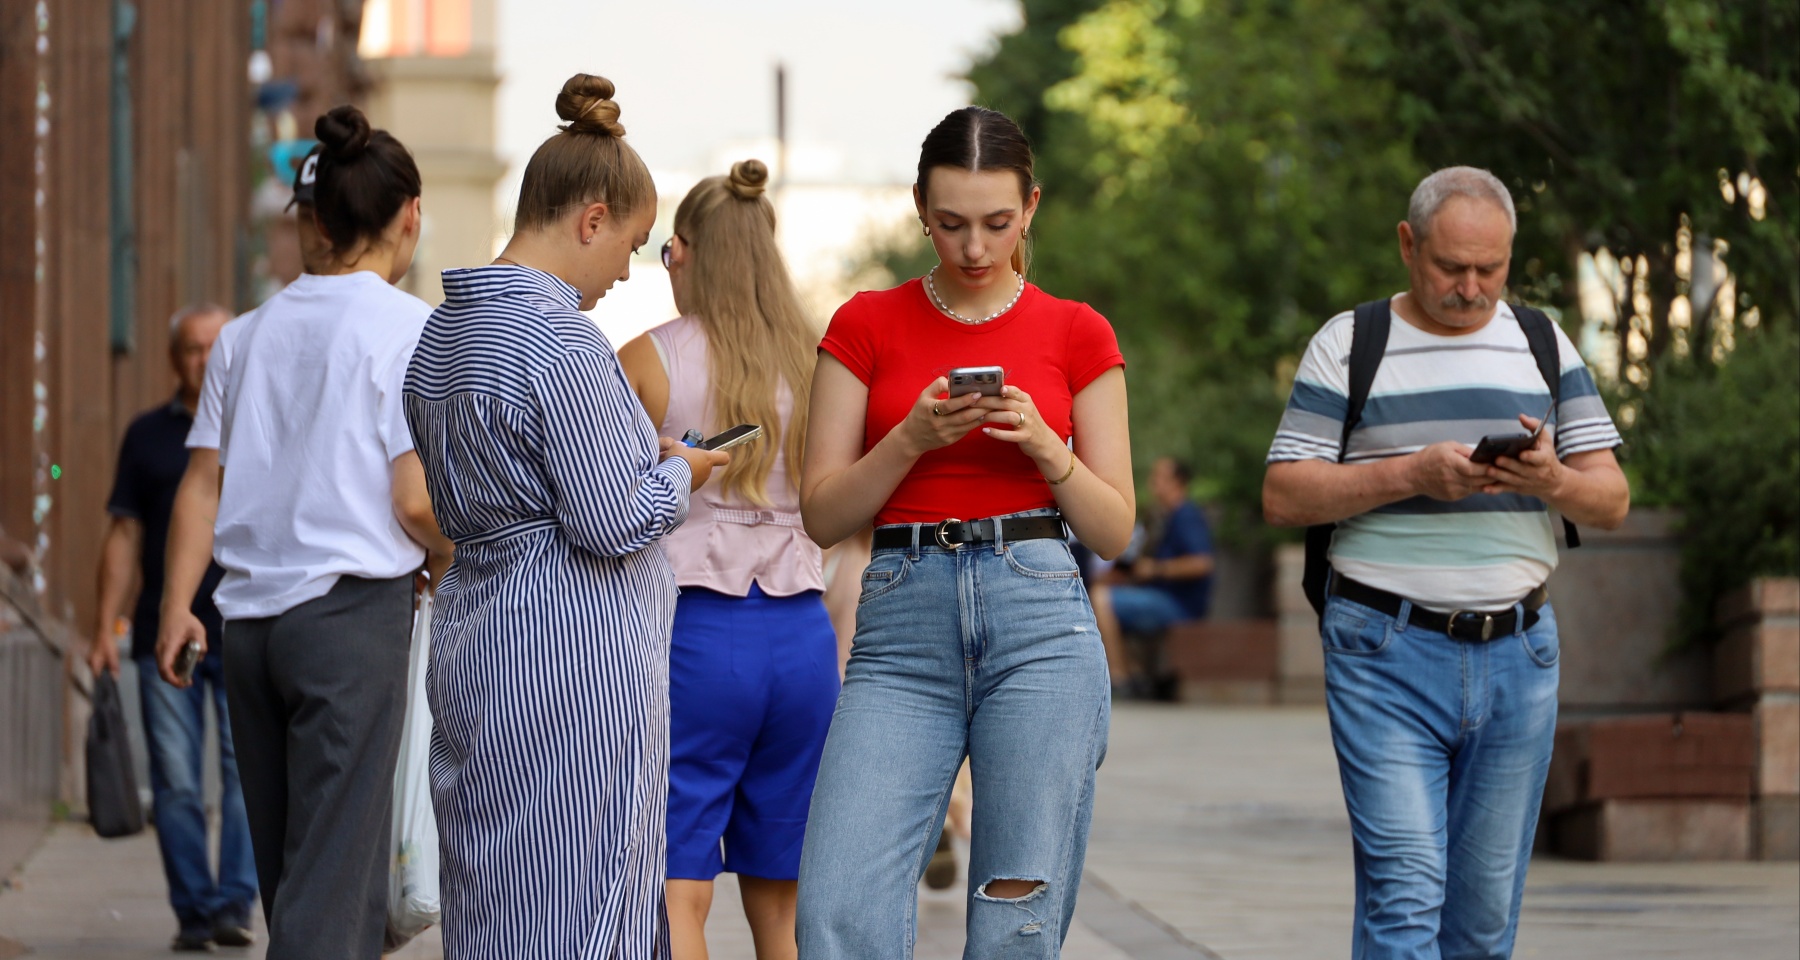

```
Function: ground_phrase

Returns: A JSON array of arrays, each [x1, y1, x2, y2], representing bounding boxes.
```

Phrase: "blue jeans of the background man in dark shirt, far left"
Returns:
[[137, 645, 256, 929]]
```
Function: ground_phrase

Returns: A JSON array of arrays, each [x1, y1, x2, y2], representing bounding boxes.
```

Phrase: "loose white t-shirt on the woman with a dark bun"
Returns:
[[187, 270, 430, 620]]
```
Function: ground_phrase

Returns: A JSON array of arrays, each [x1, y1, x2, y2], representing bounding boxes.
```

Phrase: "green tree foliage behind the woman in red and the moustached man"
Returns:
[[943, 0, 1800, 583]]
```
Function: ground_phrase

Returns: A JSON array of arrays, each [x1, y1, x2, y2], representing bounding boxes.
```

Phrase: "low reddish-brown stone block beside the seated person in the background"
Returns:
[[1165, 620, 1280, 704]]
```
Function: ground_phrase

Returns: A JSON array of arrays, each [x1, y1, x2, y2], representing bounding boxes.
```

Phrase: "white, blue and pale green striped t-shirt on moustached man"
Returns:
[[1269, 303, 1620, 611]]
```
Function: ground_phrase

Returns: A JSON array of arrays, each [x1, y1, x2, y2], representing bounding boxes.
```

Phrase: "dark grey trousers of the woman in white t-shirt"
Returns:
[[225, 576, 412, 960]]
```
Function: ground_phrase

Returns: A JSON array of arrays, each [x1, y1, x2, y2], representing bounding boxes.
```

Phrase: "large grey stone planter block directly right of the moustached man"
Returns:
[[1550, 510, 1715, 713]]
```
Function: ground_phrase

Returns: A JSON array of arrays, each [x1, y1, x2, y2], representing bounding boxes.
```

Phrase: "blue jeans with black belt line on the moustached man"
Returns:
[[1321, 596, 1559, 960]]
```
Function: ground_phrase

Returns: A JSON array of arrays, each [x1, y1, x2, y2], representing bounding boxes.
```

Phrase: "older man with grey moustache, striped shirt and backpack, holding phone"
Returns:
[[1264, 168, 1631, 960]]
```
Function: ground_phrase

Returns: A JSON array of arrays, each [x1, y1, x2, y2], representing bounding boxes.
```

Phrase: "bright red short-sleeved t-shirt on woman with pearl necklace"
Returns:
[[819, 279, 1125, 526]]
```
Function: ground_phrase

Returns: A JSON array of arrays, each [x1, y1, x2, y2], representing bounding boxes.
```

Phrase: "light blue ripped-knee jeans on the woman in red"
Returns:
[[797, 512, 1111, 960]]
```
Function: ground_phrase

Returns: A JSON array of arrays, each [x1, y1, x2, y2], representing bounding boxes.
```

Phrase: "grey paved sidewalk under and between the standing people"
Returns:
[[0, 706, 1800, 960]]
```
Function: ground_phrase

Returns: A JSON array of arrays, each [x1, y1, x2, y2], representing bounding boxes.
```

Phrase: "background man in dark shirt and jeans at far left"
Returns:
[[88, 306, 256, 951]]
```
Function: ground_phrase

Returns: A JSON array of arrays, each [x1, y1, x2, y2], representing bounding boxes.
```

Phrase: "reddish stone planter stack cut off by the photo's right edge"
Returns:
[[1712, 576, 1800, 861]]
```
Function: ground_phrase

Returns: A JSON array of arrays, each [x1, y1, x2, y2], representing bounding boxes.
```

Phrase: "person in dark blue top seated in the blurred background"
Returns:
[[1094, 457, 1213, 699]]
